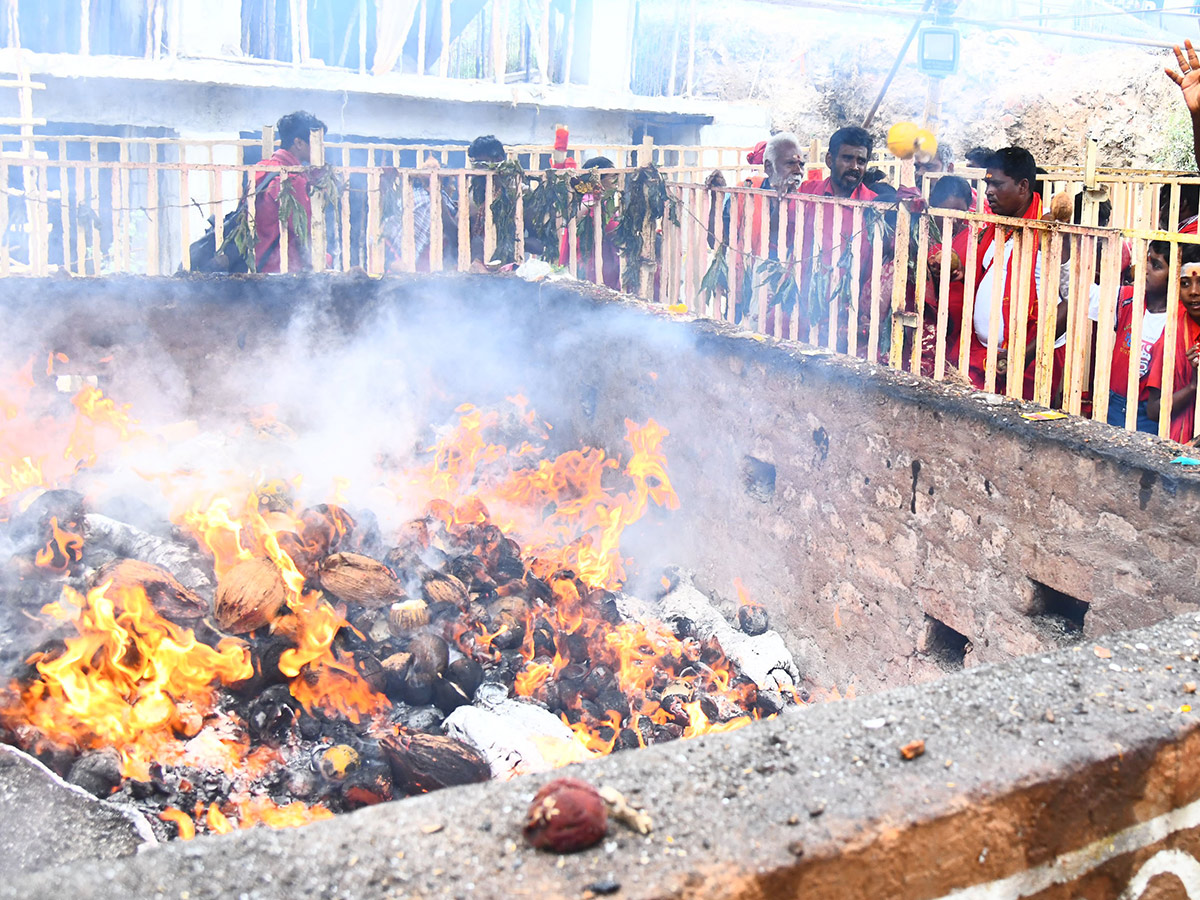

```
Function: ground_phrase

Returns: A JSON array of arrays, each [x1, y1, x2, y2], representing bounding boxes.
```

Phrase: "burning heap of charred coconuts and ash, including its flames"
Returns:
[[0, 355, 799, 839]]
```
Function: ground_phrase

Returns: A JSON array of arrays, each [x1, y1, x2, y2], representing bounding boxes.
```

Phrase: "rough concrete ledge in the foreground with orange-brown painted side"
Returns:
[[0, 617, 1200, 900]]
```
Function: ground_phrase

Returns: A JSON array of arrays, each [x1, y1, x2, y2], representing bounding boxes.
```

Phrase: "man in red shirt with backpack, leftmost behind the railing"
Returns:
[[254, 112, 325, 272]]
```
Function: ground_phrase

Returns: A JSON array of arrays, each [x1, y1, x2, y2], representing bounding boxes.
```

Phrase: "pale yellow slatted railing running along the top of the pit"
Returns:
[[7, 139, 1200, 448]]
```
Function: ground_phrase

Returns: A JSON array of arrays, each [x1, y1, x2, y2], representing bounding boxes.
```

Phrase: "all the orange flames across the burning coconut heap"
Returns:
[[0, 362, 806, 839]]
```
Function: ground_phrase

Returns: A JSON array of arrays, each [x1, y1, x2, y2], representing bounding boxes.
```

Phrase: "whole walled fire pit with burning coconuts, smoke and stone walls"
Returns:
[[0, 278, 1196, 900]]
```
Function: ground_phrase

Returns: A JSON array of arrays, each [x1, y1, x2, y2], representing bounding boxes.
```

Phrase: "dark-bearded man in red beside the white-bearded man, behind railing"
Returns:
[[799, 126, 875, 352]]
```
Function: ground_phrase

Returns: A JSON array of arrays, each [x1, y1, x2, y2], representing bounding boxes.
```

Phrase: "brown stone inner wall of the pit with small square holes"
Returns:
[[556, 316, 1200, 690]]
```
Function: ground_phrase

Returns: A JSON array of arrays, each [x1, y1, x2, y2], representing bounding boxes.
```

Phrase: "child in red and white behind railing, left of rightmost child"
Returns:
[[1109, 241, 1171, 434]]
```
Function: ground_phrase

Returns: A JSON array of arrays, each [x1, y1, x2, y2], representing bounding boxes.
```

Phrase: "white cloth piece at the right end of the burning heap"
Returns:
[[659, 582, 800, 690]]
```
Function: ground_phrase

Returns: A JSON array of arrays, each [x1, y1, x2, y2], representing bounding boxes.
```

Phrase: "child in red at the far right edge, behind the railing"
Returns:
[[1146, 244, 1200, 444]]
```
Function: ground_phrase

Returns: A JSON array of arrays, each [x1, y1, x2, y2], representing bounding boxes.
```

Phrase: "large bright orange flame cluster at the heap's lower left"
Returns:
[[0, 583, 253, 779]]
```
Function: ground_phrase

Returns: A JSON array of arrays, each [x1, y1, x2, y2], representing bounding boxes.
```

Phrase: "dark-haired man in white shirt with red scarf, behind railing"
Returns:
[[968, 146, 1067, 400]]
